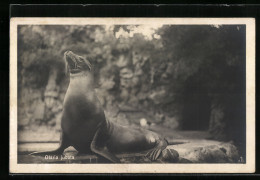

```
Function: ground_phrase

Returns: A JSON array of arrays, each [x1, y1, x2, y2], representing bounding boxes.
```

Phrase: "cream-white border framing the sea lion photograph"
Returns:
[[9, 18, 255, 173]]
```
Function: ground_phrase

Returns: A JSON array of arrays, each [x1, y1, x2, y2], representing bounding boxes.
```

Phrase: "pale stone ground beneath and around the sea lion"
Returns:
[[18, 126, 245, 164]]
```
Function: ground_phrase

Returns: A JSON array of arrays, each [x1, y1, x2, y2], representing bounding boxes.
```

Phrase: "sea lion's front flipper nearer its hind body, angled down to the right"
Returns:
[[90, 129, 120, 163]]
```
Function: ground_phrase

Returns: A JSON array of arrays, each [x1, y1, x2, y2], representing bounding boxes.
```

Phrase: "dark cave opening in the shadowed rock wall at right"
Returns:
[[181, 71, 211, 131]]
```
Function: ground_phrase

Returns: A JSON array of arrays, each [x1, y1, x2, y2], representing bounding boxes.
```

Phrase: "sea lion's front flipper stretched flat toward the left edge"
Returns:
[[29, 133, 70, 156]]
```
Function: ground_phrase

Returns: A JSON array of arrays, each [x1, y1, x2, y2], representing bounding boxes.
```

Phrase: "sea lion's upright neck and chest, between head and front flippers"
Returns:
[[61, 69, 105, 152]]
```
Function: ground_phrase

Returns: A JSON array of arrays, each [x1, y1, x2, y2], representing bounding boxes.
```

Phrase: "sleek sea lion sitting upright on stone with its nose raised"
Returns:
[[31, 51, 171, 163]]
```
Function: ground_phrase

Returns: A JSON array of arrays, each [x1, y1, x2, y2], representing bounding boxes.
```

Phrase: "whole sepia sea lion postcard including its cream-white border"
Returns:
[[10, 18, 255, 173]]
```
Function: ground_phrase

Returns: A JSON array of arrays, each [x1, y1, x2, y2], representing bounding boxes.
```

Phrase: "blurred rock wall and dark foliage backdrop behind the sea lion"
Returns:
[[18, 25, 246, 160]]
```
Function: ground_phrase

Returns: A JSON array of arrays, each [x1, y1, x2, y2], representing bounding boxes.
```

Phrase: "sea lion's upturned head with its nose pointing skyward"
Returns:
[[64, 51, 91, 75]]
